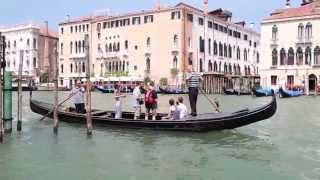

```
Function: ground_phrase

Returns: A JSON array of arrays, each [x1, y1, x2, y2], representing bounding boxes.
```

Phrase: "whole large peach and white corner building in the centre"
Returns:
[[59, 3, 260, 92]]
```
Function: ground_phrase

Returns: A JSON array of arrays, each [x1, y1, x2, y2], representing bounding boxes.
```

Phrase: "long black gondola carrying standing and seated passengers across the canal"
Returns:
[[30, 96, 277, 132]]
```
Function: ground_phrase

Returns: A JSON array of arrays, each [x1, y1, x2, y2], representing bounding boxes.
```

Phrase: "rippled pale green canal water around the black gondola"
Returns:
[[0, 92, 320, 180]]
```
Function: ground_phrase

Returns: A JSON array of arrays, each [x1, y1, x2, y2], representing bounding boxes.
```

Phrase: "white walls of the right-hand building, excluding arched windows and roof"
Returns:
[[261, 17, 320, 93]]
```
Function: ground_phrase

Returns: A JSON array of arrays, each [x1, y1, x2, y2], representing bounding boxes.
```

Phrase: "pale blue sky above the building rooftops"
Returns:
[[0, 0, 301, 30]]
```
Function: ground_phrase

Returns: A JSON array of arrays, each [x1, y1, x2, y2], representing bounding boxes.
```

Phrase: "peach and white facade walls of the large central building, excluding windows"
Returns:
[[59, 5, 260, 90]]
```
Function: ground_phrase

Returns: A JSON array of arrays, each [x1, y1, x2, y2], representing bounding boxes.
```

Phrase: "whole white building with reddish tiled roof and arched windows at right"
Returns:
[[261, 0, 320, 94]]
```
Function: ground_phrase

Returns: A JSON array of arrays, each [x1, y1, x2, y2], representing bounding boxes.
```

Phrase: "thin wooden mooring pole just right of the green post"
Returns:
[[17, 50, 24, 132]]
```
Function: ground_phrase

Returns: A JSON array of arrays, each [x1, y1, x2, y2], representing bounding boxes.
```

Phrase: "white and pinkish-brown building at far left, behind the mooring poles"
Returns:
[[0, 23, 58, 82]]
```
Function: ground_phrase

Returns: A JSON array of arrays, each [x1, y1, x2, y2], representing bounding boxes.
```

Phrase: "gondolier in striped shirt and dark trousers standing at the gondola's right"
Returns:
[[186, 69, 202, 116]]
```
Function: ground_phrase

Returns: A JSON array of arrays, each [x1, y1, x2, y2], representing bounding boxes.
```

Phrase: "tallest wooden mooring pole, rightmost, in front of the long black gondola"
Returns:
[[84, 34, 92, 136]]
